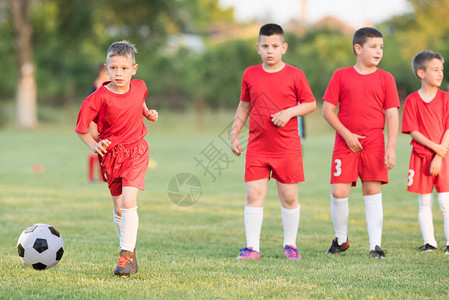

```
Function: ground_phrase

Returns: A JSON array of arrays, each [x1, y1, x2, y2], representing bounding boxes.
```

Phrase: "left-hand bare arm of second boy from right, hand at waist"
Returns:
[[323, 101, 365, 152]]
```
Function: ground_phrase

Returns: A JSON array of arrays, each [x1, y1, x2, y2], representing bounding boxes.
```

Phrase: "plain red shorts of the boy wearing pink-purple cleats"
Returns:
[[245, 154, 304, 183]]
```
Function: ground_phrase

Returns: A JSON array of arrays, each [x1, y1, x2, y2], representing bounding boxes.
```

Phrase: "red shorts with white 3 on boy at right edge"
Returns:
[[407, 151, 449, 194]]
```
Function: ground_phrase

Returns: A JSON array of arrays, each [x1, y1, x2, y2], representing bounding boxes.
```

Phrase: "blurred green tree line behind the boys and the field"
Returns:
[[0, 0, 449, 127]]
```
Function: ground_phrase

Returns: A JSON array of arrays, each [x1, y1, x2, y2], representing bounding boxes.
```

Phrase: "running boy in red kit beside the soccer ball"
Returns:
[[75, 41, 158, 276]]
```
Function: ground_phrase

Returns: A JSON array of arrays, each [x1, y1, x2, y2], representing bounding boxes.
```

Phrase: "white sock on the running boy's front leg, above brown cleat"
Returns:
[[120, 206, 139, 252]]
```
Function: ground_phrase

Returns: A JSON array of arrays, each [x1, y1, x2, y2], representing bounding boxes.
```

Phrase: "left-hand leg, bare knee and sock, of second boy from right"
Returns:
[[331, 183, 352, 245]]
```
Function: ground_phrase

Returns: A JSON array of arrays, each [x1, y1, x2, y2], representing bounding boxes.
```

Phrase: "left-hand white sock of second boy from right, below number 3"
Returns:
[[331, 194, 349, 245]]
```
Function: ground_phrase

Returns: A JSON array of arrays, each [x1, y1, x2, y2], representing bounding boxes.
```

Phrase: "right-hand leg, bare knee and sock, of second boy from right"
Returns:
[[362, 181, 383, 251]]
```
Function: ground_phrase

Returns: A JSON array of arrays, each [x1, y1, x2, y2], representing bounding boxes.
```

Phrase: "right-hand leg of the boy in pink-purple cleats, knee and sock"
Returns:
[[277, 181, 300, 248]]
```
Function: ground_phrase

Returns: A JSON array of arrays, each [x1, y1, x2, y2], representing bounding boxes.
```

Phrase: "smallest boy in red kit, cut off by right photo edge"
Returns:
[[402, 51, 449, 255]]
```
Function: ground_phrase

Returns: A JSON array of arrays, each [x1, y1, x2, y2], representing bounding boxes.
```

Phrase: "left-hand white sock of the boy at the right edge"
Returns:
[[418, 193, 437, 248]]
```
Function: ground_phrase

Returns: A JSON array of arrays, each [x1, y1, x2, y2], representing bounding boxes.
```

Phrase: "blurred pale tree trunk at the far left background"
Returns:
[[9, 0, 37, 128]]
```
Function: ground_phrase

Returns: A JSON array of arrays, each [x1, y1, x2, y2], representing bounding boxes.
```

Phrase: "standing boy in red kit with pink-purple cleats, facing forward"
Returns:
[[230, 24, 316, 260]]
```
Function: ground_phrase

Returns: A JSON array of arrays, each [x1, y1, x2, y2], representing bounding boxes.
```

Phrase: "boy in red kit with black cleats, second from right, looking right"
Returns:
[[323, 27, 399, 258]]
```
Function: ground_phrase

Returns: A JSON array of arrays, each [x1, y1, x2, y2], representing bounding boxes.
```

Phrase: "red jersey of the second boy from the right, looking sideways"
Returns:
[[323, 67, 399, 152]]
